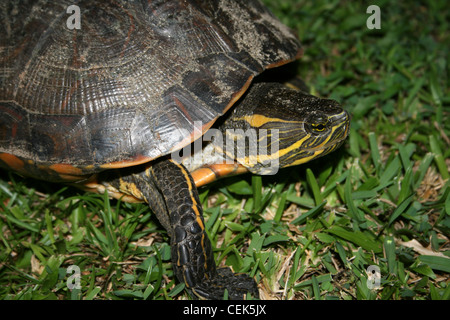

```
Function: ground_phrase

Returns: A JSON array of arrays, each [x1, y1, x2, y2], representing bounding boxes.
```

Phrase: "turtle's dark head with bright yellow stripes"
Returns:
[[216, 83, 350, 174]]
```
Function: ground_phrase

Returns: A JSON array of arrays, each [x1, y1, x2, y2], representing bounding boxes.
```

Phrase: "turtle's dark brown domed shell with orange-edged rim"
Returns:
[[0, 0, 301, 180]]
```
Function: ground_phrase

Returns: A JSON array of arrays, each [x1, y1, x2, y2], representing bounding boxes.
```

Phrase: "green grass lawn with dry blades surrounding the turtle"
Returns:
[[0, 0, 450, 300]]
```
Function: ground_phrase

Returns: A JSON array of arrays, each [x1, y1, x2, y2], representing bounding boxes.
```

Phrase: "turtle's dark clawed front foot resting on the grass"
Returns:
[[191, 268, 259, 300]]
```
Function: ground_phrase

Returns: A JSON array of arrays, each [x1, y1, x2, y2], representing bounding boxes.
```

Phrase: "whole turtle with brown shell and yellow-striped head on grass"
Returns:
[[0, 0, 349, 299]]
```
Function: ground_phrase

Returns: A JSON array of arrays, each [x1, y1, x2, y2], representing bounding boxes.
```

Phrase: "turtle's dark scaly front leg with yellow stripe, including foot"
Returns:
[[100, 160, 259, 299]]
